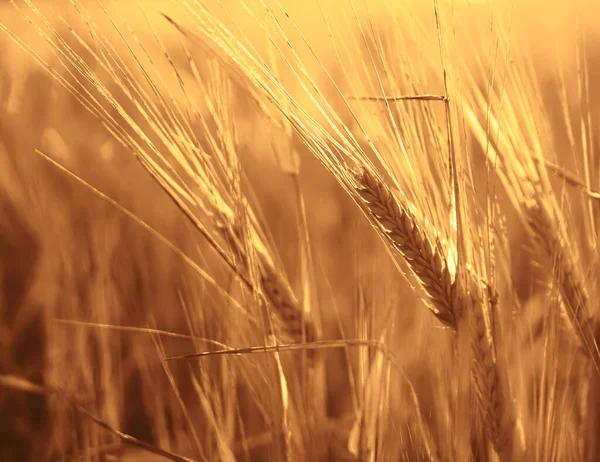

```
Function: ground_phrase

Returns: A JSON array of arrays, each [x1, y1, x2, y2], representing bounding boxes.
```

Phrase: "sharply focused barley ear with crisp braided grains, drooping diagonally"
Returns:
[[354, 168, 457, 329]]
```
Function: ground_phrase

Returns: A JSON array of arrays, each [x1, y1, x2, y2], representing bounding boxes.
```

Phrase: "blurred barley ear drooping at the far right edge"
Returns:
[[526, 201, 598, 360]]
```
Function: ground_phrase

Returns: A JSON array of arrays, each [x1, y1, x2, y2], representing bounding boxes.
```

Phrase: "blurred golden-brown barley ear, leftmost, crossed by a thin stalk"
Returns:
[[217, 219, 318, 342]]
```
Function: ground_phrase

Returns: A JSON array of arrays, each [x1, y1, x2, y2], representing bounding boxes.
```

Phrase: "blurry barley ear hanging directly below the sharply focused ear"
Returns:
[[462, 286, 514, 461]]
